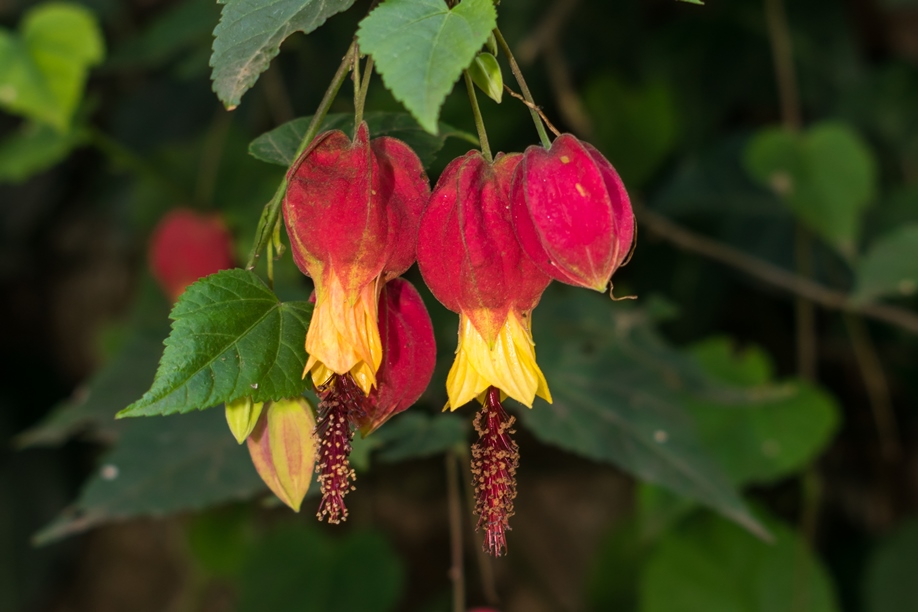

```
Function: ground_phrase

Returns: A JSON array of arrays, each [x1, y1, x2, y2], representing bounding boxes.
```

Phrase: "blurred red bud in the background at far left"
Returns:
[[148, 208, 235, 301]]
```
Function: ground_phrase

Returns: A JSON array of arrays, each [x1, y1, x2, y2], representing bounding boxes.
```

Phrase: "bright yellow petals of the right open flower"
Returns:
[[446, 312, 551, 410]]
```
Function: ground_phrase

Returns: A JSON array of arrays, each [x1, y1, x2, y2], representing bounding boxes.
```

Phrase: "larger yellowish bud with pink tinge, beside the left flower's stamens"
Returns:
[[248, 397, 316, 512]]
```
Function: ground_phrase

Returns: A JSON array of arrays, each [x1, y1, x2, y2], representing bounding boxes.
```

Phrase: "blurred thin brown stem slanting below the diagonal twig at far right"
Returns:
[[845, 314, 902, 463]]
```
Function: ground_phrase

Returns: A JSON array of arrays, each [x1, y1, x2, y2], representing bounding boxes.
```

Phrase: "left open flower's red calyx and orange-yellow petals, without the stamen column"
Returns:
[[283, 123, 430, 394]]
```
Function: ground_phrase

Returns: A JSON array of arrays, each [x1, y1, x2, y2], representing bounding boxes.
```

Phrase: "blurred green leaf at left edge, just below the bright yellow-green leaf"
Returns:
[[0, 122, 86, 183]]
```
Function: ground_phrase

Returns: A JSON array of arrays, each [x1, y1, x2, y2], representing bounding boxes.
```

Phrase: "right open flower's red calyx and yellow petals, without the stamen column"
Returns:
[[418, 151, 551, 410]]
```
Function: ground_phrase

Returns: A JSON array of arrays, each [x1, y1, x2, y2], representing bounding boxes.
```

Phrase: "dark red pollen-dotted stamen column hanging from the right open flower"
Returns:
[[472, 387, 520, 557]]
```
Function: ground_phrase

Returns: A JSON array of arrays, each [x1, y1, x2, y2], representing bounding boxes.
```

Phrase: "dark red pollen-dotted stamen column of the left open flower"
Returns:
[[316, 374, 367, 524]]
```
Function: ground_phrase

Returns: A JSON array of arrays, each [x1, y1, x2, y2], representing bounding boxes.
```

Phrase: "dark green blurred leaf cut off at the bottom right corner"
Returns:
[[864, 519, 918, 612]]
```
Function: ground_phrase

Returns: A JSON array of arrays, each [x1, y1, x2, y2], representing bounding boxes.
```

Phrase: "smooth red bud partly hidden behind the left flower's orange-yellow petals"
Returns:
[[357, 278, 437, 436]]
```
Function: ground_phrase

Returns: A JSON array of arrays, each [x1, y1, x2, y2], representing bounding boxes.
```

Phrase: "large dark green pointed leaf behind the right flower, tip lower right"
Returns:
[[517, 288, 764, 534]]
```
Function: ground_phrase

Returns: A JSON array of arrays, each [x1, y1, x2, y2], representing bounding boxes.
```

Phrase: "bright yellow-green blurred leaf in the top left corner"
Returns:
[[0, 3, 105, 132]]
